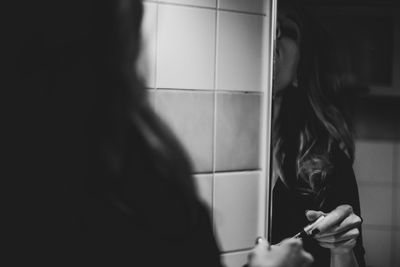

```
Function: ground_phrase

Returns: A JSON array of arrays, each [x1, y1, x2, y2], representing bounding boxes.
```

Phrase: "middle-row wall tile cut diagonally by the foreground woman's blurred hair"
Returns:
[[156, 90, 214, 172]]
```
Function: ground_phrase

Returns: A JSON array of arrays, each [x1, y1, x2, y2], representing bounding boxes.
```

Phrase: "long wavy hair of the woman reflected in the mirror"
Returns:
[[274, 2, 354, 201]]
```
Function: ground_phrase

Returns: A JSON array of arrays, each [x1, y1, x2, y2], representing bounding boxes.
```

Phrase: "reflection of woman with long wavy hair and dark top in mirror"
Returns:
[[272, 1, 365, 267]]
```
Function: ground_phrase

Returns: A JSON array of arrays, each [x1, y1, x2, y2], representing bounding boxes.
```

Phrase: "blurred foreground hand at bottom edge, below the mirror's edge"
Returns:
[[246, 239, 313, 267]]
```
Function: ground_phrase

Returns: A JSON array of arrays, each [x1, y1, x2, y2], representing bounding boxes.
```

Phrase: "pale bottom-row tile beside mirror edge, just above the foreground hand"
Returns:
[[214, 172, 264, 251]]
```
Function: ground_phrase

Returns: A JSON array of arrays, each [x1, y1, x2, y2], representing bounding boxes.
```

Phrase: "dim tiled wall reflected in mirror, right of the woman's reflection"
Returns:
[[354, 139, 400, 267]]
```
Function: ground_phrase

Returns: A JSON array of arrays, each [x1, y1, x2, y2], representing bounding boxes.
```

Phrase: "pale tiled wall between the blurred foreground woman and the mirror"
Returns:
[[139, 0, 270, 267]]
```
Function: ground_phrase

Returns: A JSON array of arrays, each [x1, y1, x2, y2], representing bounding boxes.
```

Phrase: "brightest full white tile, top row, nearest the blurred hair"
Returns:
[[157, 5, 216, 89]]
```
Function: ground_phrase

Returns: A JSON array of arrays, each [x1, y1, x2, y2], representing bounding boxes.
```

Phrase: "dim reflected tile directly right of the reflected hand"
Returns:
[[359, 185, 392, 225]]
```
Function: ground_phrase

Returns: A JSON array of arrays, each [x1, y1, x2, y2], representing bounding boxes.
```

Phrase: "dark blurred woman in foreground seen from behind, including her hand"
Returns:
[[4, 0, 312, 267]]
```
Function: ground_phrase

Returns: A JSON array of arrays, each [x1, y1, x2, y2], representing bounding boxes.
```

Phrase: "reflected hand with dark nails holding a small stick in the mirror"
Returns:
[[306, 205, 362, 254]]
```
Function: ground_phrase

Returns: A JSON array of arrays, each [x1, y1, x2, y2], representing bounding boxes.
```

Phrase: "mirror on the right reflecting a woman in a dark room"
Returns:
[[271, 0, 400, 266]]
